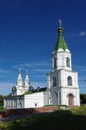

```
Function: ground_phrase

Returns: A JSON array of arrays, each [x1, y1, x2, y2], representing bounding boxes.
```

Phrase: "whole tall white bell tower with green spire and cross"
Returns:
[[48, 20, 80, 106]]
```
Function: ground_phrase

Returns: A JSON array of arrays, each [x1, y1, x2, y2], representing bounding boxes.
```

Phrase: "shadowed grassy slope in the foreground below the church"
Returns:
[[0, 106, 86, 130]]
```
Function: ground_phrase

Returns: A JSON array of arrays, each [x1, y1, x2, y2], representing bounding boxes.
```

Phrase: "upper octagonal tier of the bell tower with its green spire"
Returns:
[[52, 20, 72, 71]]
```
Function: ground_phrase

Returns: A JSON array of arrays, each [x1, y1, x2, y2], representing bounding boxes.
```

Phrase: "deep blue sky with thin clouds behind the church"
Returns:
[[0, 0, 86, 95]]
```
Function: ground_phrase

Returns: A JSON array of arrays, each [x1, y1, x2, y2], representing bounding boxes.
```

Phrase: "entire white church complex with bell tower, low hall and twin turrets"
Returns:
[[4, 20, 80, 109]]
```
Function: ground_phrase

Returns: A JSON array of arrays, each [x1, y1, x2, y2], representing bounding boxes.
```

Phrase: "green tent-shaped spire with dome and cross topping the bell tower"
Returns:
[[55, 20, 68, 50]]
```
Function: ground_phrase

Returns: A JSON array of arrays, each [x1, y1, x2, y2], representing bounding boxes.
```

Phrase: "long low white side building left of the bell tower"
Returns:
[[4, 92, 48, 109]]
